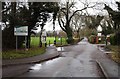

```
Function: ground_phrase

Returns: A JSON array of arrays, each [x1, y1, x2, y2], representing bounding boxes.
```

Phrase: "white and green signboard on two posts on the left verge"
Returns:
[[14, 26, 28, 51]]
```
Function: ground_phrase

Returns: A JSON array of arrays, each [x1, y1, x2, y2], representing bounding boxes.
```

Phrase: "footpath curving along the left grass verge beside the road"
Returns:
[[2, 46, 60, 67]]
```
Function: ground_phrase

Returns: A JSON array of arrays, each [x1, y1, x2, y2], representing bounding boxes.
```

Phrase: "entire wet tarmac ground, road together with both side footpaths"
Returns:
[[3, 38, 119, 79]]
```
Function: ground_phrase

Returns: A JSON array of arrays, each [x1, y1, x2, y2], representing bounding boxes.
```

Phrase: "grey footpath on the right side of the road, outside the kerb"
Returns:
[[96, 44, 120, 79]]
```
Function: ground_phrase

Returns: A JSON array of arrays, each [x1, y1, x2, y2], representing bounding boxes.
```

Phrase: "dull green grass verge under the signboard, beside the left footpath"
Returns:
[[2, 47, 45, 59]]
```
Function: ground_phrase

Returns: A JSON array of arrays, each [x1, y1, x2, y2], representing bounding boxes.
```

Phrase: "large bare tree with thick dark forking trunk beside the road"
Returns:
[[58, 1, 95, 44]]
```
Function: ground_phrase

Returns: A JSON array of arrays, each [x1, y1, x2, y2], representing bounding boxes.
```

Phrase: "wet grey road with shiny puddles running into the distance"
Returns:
[[14, 38, 103, 77]]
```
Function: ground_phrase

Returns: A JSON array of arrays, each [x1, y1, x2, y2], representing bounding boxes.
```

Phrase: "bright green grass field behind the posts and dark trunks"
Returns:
[[31, 37, 67, 46]]
